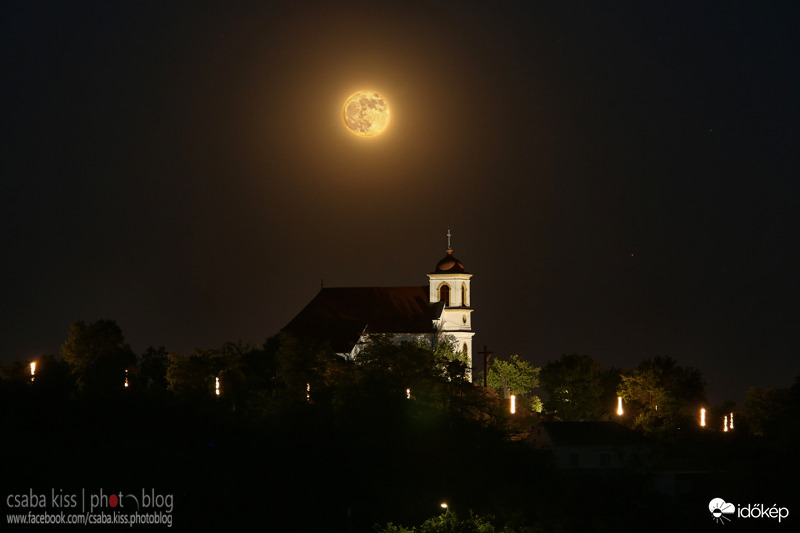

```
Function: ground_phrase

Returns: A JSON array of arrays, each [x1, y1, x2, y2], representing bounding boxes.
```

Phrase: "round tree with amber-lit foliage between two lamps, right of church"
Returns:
[[617, 357, 706, 432]]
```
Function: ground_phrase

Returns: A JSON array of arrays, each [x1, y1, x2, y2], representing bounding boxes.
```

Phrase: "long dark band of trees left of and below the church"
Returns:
[[2, 320, 502, 424]]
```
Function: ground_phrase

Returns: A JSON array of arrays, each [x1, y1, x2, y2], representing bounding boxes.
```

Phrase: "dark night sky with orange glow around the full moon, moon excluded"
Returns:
[[0, 0, 800, 402]]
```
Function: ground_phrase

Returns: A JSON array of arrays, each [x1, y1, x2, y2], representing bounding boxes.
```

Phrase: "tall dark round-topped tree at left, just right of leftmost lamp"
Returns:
[[61, 320, 136, 395]]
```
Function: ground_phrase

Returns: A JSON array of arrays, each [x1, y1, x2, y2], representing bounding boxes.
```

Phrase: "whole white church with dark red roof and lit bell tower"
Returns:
[[283, 230, 475, 374]]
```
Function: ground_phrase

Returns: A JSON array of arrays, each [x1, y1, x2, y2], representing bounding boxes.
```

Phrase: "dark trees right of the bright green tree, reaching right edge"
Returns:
[[539, 354, 800, 438]]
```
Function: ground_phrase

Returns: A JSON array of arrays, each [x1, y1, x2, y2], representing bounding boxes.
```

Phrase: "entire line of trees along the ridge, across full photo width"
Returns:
[[0, 320, 800, 435]]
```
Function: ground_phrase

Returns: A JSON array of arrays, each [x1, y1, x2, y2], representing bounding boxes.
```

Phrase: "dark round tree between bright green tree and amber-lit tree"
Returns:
[[541, 354, 619, 422]]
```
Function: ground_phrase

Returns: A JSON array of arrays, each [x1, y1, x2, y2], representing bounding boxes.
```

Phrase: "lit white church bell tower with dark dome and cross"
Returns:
[[428, 229, 475, 369]]
